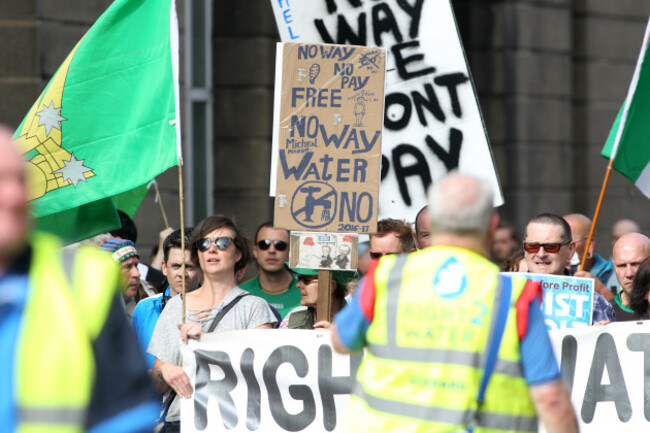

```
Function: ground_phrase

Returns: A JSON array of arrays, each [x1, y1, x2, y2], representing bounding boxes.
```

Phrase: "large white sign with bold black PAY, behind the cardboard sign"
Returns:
[[270, 0, 503, 221]]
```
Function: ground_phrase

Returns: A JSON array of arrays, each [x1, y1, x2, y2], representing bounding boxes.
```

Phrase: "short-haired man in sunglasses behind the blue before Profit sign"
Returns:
[[524, 213, 616, 324]]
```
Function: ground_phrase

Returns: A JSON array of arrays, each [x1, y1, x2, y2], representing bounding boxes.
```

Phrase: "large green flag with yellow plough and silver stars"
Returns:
[[16, 0, 180, 241]]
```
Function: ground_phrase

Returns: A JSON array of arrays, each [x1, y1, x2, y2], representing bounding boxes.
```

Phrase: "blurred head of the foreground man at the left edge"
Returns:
[[0, 125, 29, 266]]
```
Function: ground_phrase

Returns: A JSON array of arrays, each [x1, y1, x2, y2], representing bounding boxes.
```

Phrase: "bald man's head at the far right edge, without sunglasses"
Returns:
[[613, 233, 650, 296]]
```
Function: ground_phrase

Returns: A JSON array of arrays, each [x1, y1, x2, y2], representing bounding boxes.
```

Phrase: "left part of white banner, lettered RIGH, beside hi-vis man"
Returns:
[[181, 330, 361, 433]]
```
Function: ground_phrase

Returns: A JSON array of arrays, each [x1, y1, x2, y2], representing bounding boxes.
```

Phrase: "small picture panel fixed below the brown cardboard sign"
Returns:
[[289, 231, 359, 270]]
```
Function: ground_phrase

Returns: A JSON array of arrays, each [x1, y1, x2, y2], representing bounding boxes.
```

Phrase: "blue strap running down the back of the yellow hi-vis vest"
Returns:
[[466, 275, 512, 432]]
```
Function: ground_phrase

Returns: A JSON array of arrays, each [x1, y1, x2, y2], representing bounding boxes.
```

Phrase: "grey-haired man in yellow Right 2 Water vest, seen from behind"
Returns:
[[332, 174, 578, 433]]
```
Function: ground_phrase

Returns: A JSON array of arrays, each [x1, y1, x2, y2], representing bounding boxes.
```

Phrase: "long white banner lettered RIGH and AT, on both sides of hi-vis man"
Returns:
[[181, 321, 650, 433]]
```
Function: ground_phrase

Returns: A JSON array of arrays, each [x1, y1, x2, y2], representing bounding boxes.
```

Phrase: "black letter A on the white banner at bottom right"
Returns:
[[580, 333, 632, 423]]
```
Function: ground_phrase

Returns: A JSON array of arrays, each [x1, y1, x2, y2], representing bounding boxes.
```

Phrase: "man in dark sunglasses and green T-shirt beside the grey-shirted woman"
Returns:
[[240, 221, 300, 317]]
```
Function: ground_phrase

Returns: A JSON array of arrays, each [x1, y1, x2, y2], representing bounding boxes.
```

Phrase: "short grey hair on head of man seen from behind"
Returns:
[[429, 174, 494, 237]]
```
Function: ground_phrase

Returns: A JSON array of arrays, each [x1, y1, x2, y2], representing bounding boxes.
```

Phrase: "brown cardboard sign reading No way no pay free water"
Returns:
[[271, 43, 386, 233]]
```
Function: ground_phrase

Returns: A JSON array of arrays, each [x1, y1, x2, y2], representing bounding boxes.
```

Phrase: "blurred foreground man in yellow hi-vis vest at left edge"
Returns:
[[0, 125, 159, 433]]
